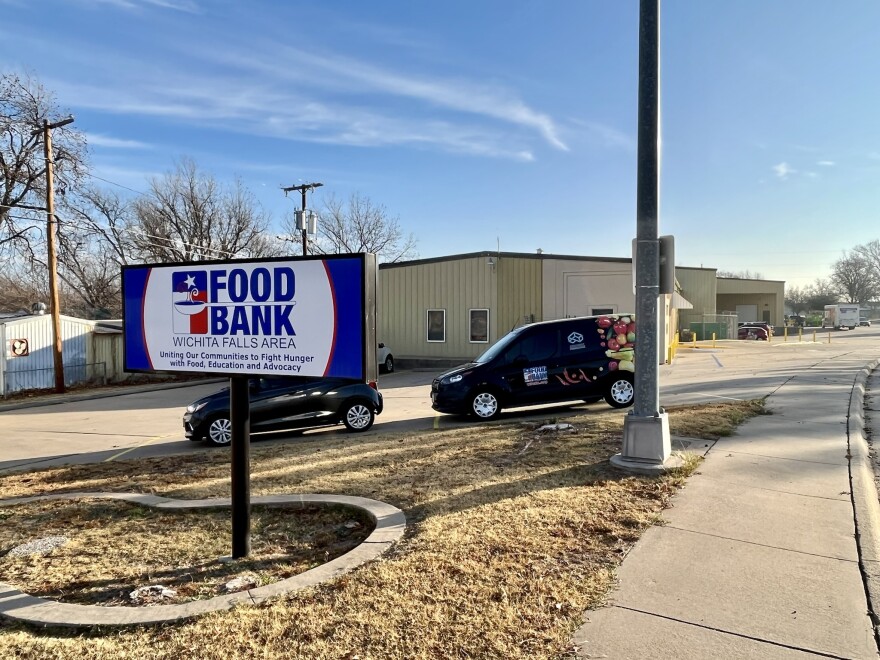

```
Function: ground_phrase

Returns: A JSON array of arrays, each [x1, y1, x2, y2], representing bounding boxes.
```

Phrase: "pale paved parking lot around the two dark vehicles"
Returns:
[[0, 327, 880, 472]]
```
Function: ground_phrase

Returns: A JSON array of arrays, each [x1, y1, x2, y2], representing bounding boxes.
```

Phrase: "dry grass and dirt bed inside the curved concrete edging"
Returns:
[[0, 500, 373, 606]]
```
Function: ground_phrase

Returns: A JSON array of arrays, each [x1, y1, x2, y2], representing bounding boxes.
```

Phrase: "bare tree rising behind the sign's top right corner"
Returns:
[[302, 193, 418, 263]]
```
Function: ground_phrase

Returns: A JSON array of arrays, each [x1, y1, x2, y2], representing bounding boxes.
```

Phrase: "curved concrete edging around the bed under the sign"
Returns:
[[0, 492, 406, 628]]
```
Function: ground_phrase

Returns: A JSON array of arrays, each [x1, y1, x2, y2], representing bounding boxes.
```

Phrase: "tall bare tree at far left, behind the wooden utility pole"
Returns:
[[0, 73, 86, 247]]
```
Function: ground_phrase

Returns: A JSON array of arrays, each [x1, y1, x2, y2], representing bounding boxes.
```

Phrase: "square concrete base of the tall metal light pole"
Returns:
[[611, 412, 684, 474]]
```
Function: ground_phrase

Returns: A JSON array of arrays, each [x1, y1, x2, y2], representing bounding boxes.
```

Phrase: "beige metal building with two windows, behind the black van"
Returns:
[[378, 252, 688, 367]]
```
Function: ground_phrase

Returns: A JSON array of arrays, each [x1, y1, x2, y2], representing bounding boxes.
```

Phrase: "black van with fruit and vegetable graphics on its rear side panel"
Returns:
[[431, 314, 636, 419]]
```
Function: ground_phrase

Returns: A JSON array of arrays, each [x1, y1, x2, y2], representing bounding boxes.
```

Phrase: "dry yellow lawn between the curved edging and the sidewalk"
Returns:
[[0, 403, 762, 658]]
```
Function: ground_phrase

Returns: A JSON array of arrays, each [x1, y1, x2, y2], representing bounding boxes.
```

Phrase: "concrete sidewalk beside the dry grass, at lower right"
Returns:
[[574, 352, 880, 660]]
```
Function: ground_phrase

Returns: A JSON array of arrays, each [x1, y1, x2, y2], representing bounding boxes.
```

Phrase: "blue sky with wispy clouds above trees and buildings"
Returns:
[[0, 0, 880, 285]]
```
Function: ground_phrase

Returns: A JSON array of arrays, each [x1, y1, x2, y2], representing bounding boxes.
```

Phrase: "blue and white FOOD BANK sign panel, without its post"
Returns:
[[122, 254, 376, 379]]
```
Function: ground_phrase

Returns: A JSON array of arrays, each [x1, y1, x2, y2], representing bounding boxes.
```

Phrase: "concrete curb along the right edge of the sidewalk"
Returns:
[[847, 359, 880, 647]]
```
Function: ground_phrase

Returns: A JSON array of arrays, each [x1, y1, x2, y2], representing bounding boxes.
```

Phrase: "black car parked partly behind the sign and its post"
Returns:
[[183, 377, 382, 447]]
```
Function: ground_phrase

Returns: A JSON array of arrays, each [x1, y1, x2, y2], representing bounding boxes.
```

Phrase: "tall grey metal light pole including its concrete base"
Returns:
[[611, 0, 673, 473]]
